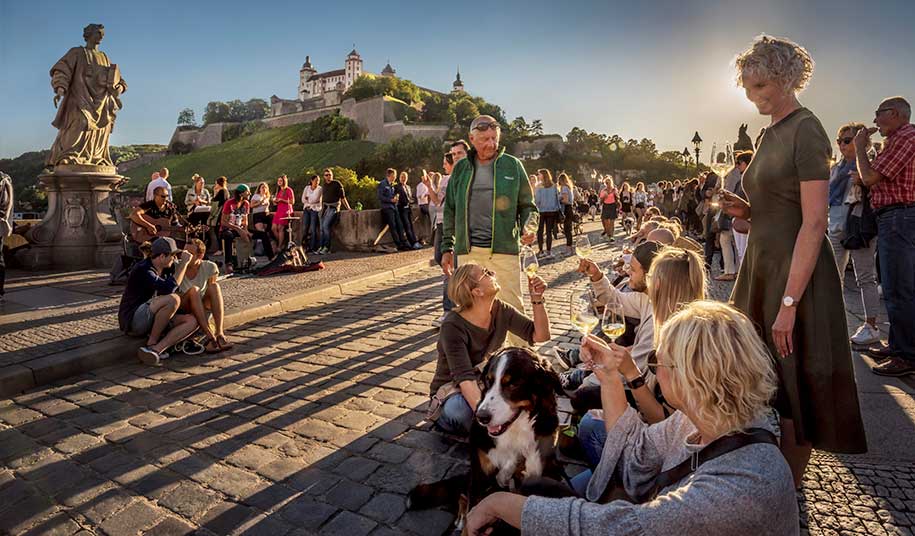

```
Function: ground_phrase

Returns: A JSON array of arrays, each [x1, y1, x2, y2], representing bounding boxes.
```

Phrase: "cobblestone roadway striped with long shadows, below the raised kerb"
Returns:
[[0, 224, 915, 536]]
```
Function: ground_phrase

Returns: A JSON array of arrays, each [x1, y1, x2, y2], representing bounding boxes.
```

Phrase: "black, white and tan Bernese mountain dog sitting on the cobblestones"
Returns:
[[407, 347, 562, 528]]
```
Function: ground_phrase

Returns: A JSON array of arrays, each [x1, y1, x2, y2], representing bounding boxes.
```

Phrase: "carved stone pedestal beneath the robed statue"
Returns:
[[17, 165, 124, 270]]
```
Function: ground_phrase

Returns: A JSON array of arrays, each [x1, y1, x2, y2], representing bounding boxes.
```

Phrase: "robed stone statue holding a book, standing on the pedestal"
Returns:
[[47, 24, 127, 168]]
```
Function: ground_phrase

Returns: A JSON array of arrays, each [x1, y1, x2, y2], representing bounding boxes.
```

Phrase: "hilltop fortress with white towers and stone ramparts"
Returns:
[[169, 47, 464, 149]]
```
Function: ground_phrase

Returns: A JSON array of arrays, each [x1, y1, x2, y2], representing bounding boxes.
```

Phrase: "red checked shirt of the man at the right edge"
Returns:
[[870, 124, 915, 209]]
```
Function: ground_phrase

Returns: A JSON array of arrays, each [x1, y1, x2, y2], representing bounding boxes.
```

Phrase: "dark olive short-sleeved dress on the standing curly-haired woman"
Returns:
[[731, 108, 867, 453]]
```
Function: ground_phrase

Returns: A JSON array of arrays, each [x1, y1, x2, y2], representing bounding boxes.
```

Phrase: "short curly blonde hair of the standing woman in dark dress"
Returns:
[[734, 34, 814, 93]]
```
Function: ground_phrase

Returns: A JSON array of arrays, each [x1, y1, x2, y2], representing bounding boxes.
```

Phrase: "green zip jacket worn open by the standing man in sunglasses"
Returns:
[[441, 148, 537, 255]]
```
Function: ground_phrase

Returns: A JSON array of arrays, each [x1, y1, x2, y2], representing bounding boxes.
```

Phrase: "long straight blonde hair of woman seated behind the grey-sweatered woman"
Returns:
[[648, 246, 708, 330]]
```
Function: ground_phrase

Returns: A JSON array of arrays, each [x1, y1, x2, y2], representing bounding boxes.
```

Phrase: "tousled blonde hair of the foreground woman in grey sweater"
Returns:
[[658, 301, 777, 434]]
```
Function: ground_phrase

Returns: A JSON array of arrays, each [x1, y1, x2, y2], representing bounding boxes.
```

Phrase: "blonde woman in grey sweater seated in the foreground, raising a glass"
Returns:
[[467, 301, 799, 536]]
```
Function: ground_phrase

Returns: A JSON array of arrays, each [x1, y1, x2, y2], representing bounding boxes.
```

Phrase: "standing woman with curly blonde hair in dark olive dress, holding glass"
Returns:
[[722, 36, 867, 485]]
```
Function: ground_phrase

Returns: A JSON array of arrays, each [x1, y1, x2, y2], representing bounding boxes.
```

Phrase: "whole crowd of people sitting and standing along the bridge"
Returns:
[[109, 30, 915, 535]]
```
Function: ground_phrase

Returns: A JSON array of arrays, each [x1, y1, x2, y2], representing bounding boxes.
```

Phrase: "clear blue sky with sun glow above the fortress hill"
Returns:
[[0, 0, 915, 160]]
